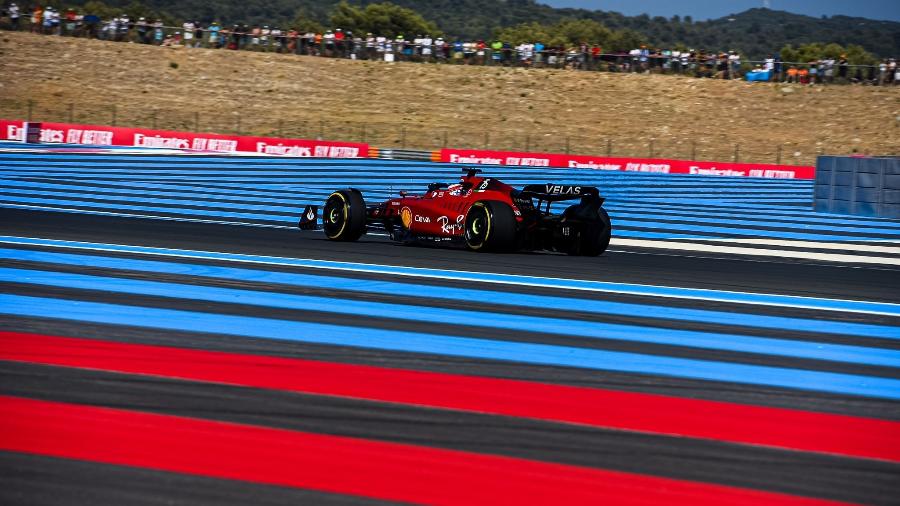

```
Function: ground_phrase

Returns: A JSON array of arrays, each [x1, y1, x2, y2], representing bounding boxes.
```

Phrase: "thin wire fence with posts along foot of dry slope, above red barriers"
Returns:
[[0, 99, 838, 165]]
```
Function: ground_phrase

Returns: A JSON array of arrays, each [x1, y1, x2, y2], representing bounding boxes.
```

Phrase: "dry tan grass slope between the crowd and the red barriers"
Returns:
[[0, 32, 900, 164]]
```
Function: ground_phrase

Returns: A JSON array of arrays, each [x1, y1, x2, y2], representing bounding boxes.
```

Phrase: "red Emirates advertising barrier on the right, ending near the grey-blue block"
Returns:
[[440, 149, 816, 179]]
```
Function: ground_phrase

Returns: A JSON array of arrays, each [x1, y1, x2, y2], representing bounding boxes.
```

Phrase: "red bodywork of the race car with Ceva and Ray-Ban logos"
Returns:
[[371, 176, 522, 237]]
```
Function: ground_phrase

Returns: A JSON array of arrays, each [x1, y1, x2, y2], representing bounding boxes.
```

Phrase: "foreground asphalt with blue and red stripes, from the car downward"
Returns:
[[0, 148, 900, 504]]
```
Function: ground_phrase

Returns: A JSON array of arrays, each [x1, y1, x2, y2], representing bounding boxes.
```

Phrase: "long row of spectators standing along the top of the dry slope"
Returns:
[[4, 3, 900, 85]]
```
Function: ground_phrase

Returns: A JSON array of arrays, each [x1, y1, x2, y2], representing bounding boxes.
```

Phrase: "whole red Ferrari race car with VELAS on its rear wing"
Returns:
[[299, 169, 612, 256]]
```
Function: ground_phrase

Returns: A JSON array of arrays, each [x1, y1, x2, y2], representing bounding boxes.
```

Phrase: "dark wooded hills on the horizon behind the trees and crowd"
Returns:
[[47, 0, 900, 59]]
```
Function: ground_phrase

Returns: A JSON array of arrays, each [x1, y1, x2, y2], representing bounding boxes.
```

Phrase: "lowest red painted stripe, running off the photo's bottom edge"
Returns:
[[0, 396, 834, 505]]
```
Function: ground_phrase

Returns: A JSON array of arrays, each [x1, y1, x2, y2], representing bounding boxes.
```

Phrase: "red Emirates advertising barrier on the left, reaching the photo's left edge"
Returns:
[[0, 120, 369, 158]]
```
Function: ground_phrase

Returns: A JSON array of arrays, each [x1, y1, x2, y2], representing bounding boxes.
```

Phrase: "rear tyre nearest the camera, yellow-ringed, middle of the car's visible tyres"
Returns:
[[463, 200, 516, 252]]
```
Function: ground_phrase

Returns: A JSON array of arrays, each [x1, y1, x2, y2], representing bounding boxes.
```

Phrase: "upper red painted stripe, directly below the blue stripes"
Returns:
[[0, 332, 900, 462]]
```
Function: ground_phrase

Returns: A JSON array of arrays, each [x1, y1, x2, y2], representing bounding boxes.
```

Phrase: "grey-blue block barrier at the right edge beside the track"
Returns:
[[814, 156, 900, 218]]
